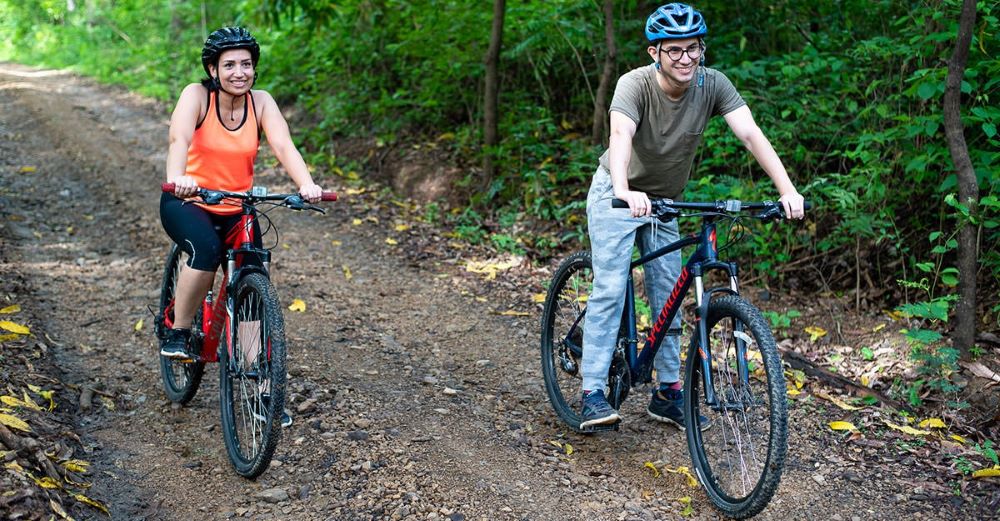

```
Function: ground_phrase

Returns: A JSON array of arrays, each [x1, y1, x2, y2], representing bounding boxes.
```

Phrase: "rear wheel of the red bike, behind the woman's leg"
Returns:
[[156, 244, 205, 405]]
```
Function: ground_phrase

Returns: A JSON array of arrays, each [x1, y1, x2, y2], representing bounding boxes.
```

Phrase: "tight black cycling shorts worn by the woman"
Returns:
[[160, 192, 261, 272]]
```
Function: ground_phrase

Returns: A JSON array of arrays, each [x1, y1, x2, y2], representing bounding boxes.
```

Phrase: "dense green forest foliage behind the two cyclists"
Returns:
[[0, 0, 1000, 322]]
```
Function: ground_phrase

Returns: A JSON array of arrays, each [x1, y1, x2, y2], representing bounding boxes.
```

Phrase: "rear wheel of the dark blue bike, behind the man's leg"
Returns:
[[541, 251, 594, 431]]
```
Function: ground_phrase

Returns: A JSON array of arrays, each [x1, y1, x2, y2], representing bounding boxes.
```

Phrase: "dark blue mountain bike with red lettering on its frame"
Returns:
[[541, 199, 809, 518]]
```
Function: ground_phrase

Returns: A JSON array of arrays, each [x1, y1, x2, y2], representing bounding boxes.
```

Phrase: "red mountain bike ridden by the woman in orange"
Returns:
[[154, 183, 337, 478]]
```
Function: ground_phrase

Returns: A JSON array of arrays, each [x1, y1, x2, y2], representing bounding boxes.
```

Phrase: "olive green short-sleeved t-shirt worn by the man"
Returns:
[[600, 64, 746, 199]]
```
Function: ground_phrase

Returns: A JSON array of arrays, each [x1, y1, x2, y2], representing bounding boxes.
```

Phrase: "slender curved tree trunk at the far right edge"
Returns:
[[944, 0, 979, 359]]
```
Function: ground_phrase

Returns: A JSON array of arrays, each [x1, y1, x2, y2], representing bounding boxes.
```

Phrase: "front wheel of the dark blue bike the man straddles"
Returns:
[[684, 295, 788, 519]]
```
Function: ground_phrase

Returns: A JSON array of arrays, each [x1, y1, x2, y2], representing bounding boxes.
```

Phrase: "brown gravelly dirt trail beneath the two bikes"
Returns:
[[0, 64, 982, 520]]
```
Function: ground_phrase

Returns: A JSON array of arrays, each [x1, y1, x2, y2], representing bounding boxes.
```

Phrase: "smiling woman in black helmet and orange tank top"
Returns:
[[160, 27, 323, 384]]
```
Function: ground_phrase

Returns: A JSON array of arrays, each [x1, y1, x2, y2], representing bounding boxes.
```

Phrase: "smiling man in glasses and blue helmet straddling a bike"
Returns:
[[580, 3, 804, 430]]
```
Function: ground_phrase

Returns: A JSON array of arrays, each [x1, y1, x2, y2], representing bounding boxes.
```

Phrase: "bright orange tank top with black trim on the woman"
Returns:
[[187, 92, 260, 215]]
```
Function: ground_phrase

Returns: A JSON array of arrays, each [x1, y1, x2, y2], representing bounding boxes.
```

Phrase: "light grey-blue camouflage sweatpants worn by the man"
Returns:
[[581, 167, 681, 391]]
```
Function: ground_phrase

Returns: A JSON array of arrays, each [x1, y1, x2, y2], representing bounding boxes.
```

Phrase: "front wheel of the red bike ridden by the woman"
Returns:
[[219, 273, 285, 478]]
